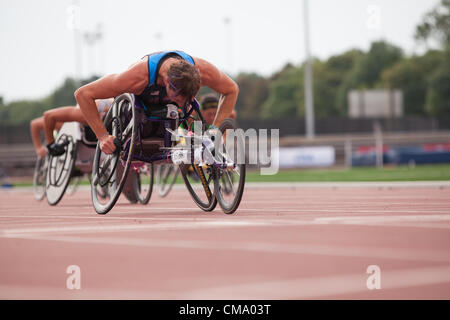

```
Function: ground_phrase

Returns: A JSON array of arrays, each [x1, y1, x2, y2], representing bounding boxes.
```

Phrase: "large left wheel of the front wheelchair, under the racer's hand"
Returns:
[[91, 94, 136, 214]]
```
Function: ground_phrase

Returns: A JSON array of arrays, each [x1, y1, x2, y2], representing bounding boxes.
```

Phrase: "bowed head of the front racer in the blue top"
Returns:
[[166, 59, 200, 107]]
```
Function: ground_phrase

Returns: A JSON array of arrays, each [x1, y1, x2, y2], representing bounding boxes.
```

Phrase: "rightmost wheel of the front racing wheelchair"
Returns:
[[214, 119, 245, 214]]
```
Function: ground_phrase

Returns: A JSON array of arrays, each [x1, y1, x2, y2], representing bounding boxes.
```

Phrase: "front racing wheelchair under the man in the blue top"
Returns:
[[91, 93, 245, 214]]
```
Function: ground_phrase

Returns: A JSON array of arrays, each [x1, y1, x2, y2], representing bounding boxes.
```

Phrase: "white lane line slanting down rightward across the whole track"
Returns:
[[6, 234, 450, 262]]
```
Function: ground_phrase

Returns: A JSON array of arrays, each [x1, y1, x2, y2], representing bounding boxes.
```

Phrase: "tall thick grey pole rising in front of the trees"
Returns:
[[303, 0, 314, 139]]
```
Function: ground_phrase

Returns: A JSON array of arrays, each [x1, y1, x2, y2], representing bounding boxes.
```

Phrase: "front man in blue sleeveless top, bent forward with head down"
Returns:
[[75, 51, 239, 154]]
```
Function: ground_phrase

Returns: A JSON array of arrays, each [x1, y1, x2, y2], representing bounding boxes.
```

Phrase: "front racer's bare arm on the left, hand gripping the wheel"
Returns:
[[75, 60, 148, 154]]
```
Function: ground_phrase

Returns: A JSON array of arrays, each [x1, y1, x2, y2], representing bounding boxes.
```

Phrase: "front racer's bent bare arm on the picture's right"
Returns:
[[194, 58, 239, 127]]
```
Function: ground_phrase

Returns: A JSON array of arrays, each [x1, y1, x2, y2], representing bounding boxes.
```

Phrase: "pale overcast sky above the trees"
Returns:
[[0, 0, 439, 102]]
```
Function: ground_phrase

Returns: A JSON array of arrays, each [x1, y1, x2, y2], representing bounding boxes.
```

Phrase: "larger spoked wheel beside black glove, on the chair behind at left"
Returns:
[[46, 122, 77, 206]]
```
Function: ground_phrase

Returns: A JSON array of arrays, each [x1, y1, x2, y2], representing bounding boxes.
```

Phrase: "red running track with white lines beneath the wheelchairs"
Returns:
[[0, 183, 450, 299]]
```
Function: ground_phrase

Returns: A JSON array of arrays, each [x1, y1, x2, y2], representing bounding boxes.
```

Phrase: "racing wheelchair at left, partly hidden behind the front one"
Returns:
[[33, 122, 153, 205]]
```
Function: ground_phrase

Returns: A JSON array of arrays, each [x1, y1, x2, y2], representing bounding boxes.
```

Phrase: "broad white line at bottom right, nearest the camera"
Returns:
[[182, 266, 450, 300]]
